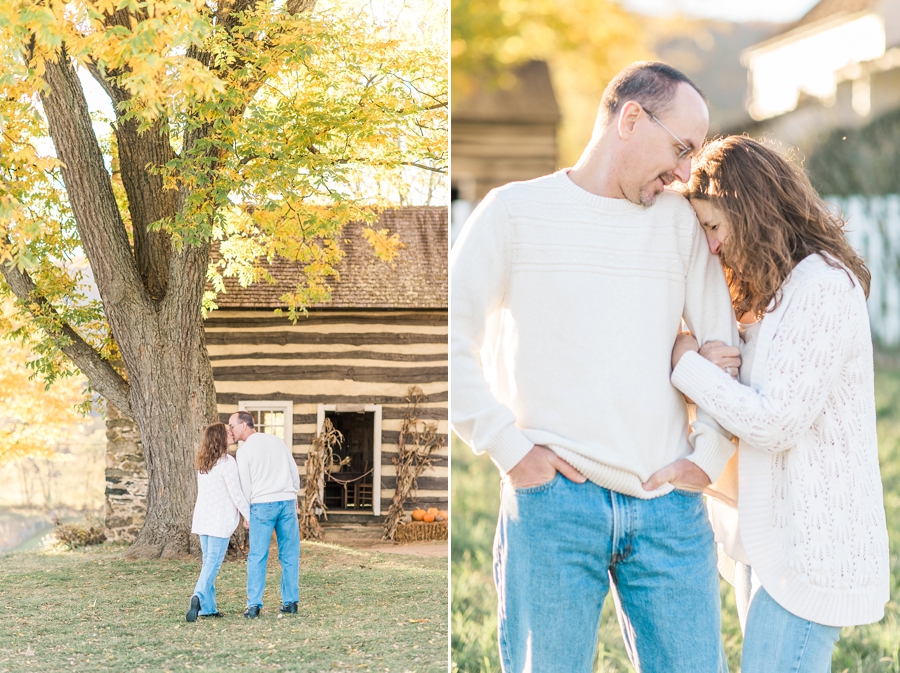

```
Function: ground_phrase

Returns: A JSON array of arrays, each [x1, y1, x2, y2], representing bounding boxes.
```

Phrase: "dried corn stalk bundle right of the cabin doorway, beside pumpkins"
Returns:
[[382, 386, 444, 540]]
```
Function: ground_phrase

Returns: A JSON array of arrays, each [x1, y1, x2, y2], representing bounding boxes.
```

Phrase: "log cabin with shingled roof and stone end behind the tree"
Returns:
[[106, 207, 449, 541]]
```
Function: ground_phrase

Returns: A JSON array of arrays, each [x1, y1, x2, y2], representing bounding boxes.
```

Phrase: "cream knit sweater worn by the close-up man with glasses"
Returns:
[[450, 170, 738, 498]]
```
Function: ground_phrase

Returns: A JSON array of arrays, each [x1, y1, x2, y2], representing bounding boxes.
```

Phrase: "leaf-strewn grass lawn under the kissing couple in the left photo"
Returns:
[[0, 542, 447, 673]]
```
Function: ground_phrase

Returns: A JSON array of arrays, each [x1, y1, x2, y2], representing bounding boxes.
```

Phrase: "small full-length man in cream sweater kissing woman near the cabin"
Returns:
[[228, 411, 300, 619]]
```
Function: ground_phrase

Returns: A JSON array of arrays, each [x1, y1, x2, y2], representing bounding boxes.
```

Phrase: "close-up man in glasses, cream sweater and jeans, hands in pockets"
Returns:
[[450, 62, 738, 673]]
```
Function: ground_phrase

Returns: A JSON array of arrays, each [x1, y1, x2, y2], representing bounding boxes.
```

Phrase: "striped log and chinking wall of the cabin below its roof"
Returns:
[[206, 309, 449, 513]]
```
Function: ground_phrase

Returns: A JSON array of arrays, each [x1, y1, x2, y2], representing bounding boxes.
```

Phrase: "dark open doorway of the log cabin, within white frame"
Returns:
[[323, 411, 375, 511]]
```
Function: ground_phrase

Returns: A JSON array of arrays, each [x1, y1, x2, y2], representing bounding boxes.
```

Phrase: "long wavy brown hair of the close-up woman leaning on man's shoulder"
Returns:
[[680, 136, 871, 317]]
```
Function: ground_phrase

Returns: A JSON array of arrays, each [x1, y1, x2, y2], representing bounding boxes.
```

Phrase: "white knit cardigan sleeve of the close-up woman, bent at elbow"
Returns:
[[672, 273, 865, 453]]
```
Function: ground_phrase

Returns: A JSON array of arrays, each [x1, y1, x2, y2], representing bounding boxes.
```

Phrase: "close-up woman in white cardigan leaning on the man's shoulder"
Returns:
[[672, 137, 890, 673]]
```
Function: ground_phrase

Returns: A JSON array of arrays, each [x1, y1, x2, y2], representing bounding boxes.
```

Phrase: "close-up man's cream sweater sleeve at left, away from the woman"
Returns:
[[450, 192, 533, 472]]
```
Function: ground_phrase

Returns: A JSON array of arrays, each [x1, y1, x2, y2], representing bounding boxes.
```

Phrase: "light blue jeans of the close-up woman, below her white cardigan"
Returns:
[[734, 563, 841, 673]]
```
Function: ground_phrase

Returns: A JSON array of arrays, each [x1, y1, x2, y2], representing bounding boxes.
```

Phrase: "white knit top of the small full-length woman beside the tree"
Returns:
[[191, 453, 250, 537]]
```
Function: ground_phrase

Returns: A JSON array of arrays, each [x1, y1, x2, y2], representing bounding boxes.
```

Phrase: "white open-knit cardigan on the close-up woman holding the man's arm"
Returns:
[[672, 255, 890, 626]]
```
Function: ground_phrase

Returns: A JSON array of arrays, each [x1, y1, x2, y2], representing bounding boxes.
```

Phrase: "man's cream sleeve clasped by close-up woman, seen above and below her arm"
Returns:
[[676, 210, 740, 481]]
